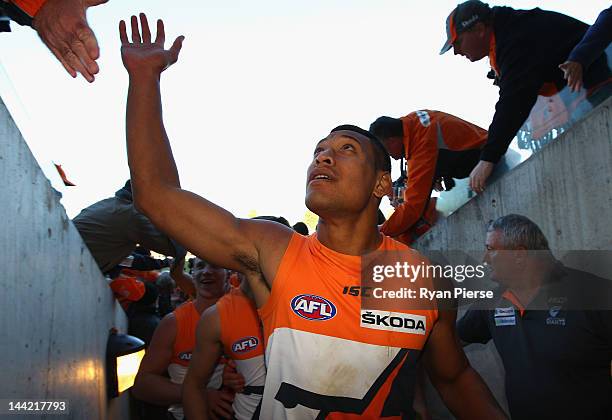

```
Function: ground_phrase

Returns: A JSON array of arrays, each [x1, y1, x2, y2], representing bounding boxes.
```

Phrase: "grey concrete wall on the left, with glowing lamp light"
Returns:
[[0, 100, 127, 419]]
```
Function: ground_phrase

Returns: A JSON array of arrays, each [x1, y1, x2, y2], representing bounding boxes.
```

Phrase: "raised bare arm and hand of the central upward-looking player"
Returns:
[[119, 14, 292, 288]]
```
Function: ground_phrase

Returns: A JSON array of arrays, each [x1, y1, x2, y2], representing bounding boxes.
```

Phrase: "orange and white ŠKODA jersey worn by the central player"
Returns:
[[259, 234, 438, 419]]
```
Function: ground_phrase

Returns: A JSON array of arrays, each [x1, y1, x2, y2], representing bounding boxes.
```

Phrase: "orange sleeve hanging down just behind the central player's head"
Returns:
[[381, 124, 438, 236]]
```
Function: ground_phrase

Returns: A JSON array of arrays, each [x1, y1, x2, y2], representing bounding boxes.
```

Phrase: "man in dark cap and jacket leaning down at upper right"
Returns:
[[440, 0, 610, 192]]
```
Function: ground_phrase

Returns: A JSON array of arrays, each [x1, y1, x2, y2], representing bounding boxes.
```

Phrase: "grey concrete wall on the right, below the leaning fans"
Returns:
[[416, 98, 612, 419]]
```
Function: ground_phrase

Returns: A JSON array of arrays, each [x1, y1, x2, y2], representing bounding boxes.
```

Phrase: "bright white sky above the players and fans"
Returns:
[[0, 0, 609, 226]]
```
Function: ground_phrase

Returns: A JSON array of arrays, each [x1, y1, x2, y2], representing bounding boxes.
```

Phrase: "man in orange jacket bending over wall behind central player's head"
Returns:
[[370, 110, 487, 244]]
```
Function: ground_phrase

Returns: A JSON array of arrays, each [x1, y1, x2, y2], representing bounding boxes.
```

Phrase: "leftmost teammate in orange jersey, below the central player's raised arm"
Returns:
[[133, 258, 233, 420]]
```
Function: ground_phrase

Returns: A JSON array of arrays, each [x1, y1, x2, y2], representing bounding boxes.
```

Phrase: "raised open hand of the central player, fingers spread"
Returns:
[[119, 13, 185, 75]]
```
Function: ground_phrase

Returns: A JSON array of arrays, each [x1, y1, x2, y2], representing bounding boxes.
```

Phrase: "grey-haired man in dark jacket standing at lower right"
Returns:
[[457, 214, 612, 420]]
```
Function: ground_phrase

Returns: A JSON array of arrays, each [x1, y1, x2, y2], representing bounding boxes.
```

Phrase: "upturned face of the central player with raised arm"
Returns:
[[306, 132, 376, 216]]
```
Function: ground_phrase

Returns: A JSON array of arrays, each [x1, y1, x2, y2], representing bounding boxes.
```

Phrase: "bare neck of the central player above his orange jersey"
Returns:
[[317, 219, 382, 255]]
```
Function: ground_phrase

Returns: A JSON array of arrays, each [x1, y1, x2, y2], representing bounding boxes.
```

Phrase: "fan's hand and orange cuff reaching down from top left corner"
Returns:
[[0, 0, 108, 83]]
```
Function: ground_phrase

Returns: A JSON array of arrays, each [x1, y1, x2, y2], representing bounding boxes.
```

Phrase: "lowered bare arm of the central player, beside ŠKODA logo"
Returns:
[[424, 310, 507, 420]]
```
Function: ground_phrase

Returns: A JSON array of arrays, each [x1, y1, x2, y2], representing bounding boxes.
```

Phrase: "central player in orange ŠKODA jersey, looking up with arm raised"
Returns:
[[119, 15, 505, 419]]
